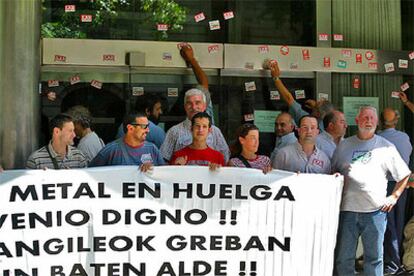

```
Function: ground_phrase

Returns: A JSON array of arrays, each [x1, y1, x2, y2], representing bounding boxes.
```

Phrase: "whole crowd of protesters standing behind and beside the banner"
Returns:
[[3, 45, 414, 275]]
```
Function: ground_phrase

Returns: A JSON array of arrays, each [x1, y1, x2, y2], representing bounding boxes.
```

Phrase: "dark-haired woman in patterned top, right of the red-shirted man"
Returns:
[[228, 123, 272, 173]]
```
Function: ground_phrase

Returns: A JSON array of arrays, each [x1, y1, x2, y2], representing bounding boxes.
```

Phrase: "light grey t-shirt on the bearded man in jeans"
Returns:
[[332, 135, 411, 213]]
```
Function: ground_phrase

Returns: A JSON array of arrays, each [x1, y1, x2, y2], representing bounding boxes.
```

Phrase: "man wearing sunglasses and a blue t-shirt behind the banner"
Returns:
[[89, 113, 165, 172]]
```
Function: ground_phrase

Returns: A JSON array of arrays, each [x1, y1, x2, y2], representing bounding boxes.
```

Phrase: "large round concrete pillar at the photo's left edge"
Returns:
[[0, 0, 41, 169]]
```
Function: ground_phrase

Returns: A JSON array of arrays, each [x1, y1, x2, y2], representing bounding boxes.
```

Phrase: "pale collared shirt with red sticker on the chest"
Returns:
[[272, 142, 331, 174]]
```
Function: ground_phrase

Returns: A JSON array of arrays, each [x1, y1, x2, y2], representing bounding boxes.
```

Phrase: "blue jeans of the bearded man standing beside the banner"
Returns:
[[335, 210, 387, 276]]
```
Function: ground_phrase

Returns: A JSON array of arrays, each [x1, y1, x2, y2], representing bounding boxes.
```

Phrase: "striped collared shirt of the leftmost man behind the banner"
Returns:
[[26, 141, 87, 169]]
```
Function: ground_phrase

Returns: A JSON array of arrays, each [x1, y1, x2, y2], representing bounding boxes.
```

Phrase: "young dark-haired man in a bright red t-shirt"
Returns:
[[170, 112, 225, 170]]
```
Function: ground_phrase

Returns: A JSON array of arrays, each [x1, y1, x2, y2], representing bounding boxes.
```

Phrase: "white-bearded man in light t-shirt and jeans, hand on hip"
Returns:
[[332, 106, 411, 275]]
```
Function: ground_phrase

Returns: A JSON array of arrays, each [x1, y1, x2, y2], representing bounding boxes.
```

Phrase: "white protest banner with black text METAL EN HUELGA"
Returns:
[[0, 166, 343, 276]]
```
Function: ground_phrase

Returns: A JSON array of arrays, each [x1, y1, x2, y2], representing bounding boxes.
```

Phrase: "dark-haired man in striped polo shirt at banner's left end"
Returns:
[[26, 114, 87, 170]]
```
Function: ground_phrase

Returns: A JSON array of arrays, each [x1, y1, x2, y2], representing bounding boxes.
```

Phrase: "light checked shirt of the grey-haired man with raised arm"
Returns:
[[160, 118, 230, 163]]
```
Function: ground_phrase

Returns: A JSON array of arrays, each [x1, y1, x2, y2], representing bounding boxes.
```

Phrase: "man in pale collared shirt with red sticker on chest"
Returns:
[[272, 115, 331, 173]]
